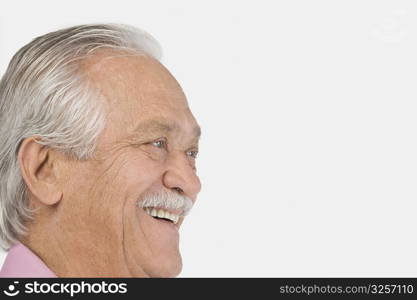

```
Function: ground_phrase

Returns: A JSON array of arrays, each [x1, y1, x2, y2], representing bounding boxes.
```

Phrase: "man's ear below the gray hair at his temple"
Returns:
[[18, 137, 62, 205]]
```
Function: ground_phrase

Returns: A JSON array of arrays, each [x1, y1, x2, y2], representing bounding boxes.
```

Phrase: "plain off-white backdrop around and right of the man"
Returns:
[[0, 0, 417, 277]]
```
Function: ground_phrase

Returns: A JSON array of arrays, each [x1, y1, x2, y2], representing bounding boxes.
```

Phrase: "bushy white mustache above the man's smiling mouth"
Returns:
[[138, 190, 193, 217]]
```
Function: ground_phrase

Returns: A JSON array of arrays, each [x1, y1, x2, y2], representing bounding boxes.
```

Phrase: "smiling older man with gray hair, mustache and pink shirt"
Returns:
[[0, 24, 200, 277]]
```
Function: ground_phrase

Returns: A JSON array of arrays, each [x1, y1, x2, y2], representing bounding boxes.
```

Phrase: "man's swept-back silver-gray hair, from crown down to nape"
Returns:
[[0, 24, 161, 250]]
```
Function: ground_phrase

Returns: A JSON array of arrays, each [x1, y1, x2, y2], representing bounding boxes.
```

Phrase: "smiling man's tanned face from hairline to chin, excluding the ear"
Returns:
[[51, 54, 200, 277]]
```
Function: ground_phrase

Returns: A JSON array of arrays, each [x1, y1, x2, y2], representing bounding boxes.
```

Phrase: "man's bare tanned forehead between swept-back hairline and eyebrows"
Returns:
[[84, 53, 198, 141]]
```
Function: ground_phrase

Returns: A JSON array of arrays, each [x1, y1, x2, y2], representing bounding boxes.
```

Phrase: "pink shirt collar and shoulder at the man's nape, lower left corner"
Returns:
[[0, 243, 57, 277]]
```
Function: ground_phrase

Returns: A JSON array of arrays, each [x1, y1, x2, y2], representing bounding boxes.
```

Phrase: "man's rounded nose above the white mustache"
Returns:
[[163, 151, 201, 201]]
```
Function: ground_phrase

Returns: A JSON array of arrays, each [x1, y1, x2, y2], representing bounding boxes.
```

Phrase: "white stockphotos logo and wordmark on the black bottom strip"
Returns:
[[0, 280, 127, 298]]
